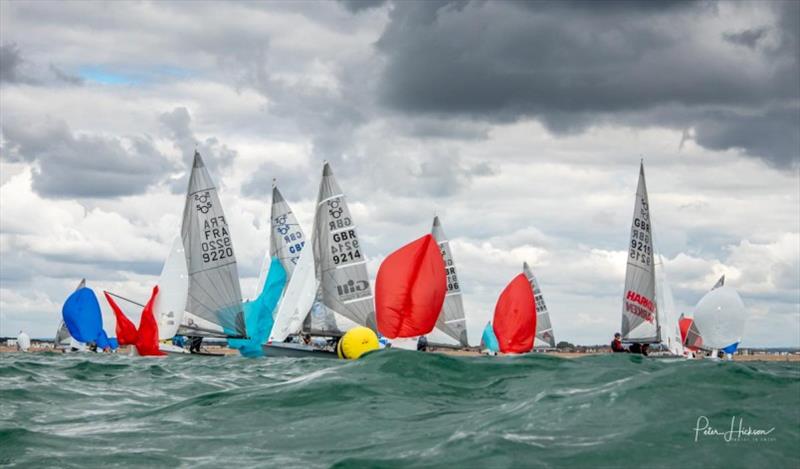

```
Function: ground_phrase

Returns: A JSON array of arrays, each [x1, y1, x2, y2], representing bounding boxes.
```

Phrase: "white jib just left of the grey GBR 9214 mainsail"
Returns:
[[269, 236, 318, 342]]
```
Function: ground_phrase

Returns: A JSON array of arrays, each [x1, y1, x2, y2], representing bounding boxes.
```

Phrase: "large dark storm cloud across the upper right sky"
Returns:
[[377, 1, 800, 167]]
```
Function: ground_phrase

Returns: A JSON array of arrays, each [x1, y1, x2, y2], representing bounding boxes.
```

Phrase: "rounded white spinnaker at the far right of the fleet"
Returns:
[[694, 286, 747, 349]]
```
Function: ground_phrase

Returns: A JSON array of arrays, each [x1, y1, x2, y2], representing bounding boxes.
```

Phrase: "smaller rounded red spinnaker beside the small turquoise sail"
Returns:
[[492, 274, 536, 353]]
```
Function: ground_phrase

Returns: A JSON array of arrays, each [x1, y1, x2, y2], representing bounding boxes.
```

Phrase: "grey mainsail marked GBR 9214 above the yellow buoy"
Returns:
[[312, 163, 377, 330]]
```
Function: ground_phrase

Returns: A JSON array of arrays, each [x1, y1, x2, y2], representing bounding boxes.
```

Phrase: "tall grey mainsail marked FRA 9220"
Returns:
[[181, 152, 246, 337]]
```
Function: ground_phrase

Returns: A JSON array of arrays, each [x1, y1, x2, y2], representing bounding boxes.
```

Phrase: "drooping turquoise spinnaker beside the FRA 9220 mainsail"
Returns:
[[228, 257, 286, 357]]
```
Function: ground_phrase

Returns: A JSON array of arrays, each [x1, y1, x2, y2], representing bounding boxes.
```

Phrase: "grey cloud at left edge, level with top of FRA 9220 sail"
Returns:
[[0, 120, 172, 198]]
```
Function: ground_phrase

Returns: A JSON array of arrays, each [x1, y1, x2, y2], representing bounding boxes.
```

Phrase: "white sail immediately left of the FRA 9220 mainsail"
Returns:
[[153, 236, 189, 340]]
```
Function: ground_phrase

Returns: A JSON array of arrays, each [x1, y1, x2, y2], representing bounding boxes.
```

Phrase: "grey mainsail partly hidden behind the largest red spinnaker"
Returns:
[[431, 216, 469, 347]]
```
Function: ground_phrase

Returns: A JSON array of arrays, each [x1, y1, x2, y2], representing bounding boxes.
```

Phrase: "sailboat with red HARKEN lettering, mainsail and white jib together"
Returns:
[[621, 162, 683, 356]]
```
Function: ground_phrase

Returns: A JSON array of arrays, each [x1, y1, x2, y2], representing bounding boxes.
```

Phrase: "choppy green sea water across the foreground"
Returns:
[[0, 350, 800, 468]]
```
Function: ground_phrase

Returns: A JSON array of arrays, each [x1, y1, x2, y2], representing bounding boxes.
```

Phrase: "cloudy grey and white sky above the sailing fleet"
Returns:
[[0, 0, 800, 346]]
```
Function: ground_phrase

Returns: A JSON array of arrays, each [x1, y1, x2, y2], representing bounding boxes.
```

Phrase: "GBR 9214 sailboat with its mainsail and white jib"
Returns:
[[265, 162, 377, 358]]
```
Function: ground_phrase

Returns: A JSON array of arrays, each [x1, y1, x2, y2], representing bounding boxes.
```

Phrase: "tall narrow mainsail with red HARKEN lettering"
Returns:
[[622, 163, 661, 343]]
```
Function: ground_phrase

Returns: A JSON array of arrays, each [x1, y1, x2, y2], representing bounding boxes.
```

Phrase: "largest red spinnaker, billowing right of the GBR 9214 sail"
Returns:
[[375, 234, 446, 339]]
